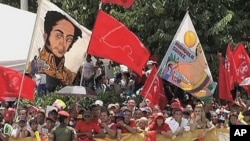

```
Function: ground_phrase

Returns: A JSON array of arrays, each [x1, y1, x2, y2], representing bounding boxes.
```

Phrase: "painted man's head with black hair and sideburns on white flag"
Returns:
[[44, 11, 82, 58]]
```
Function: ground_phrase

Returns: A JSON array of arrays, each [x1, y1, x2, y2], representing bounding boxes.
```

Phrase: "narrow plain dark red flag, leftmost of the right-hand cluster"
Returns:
[[219, 54, 233, 101]]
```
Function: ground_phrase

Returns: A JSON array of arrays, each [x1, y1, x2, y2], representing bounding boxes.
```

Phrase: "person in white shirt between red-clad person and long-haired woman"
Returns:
[[165, 108, 190, 136]]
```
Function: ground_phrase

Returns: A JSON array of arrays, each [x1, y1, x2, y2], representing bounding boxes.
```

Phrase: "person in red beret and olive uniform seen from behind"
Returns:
[[49, 110, 77, 141]]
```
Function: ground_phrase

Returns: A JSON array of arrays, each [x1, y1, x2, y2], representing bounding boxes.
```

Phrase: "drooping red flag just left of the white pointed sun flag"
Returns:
[[141, 67, 167, 109]]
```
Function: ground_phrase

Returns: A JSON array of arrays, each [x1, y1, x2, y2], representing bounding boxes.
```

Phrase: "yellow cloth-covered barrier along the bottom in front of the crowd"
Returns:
[[9, 129, 230, 141]]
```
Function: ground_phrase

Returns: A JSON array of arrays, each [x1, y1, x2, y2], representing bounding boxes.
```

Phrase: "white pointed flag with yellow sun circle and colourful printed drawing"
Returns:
[[157, 12, 217, 98]]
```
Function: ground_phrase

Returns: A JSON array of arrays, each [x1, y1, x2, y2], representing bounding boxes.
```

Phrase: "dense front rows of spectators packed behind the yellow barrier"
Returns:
[[0, 92, 250, 141]]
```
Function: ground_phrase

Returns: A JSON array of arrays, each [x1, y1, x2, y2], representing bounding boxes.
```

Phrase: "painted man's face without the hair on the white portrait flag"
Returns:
[[46, 19, 75, 58]]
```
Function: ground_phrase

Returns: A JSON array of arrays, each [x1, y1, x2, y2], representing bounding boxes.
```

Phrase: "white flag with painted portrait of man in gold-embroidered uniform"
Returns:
[[26, 0, 91, 87]]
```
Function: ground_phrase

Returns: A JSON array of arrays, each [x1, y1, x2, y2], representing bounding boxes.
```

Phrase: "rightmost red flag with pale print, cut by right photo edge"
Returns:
[[233, 43, 250, 93]]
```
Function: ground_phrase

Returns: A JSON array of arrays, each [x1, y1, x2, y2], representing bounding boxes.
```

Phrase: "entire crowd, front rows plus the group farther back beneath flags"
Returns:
[[0, 55, 250, 141]]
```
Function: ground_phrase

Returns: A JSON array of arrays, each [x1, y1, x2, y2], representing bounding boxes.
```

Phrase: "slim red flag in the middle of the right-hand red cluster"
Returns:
[[225, 43, 236, 90]]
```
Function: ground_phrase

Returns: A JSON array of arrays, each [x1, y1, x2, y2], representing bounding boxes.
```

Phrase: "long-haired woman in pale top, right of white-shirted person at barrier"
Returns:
[[190, 104, 212, 131]]
